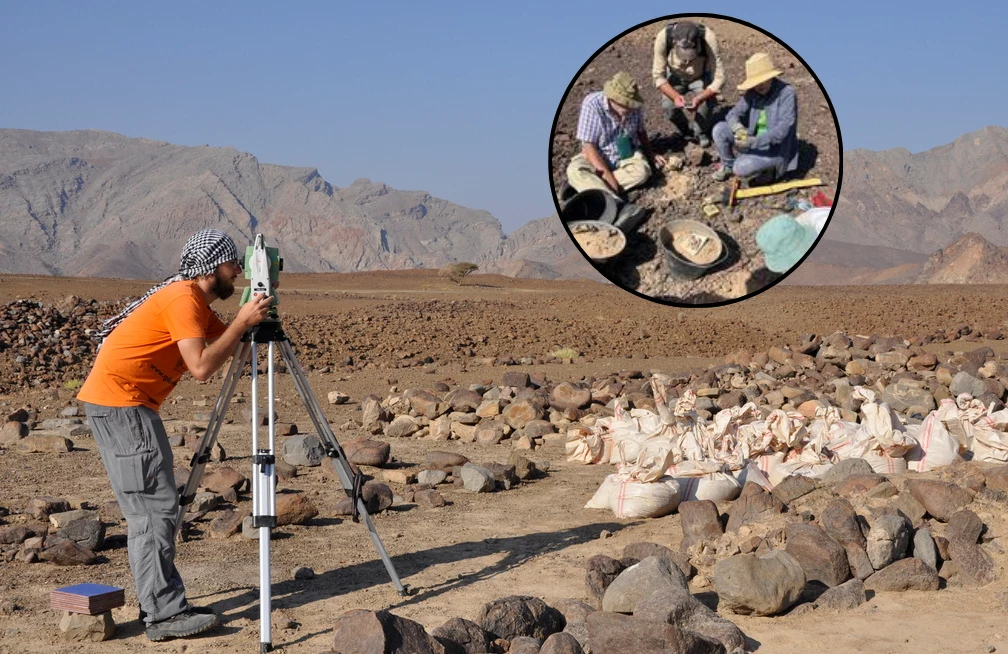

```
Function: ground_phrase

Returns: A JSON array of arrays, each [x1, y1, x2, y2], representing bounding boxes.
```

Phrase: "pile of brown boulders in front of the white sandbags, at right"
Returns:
[[587, 459, 1008, 620]]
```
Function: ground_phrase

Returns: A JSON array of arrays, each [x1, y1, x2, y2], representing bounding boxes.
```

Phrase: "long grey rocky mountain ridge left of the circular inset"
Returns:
[[0, 129, 597, 278]]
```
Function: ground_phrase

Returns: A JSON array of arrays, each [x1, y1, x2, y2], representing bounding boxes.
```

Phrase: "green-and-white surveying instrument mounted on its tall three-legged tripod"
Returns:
[[175, 234, 406, 652]]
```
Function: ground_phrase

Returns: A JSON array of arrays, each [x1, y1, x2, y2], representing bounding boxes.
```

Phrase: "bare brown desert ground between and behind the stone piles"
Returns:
[[0, 271, 1008, 654]]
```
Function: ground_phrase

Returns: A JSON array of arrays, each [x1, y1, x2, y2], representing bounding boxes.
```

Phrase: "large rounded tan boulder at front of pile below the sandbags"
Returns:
[[713, 548, 805, 616]]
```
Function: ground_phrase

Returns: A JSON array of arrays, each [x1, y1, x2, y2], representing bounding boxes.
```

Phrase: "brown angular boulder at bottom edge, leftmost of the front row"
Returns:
[[333, 609, 445, 654]]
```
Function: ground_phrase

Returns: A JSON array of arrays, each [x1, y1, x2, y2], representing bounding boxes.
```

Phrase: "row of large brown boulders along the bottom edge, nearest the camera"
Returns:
[[333, 588, 733, 654]]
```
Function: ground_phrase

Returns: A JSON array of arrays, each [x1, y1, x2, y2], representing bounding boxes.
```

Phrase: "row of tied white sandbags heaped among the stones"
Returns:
[[566, 375, 1008, 517]]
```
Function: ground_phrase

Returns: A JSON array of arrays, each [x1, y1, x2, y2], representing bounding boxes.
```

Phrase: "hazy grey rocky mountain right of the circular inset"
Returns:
[[828, 127, 1008, 254]]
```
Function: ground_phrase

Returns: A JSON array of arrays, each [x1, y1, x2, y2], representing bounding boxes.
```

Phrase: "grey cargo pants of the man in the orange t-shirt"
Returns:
[[84, 403, 188, 624]]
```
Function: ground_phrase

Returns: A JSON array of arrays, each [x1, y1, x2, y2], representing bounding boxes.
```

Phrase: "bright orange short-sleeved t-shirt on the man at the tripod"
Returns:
[[77, 281, 227, 411]]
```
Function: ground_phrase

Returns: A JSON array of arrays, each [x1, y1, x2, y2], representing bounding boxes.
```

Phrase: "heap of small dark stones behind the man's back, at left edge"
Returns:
[[0, 295, 122, 392]]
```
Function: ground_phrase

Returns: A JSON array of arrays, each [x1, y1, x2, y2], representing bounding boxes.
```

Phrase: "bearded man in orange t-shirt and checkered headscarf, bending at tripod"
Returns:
[[77, 230, 270, 641]]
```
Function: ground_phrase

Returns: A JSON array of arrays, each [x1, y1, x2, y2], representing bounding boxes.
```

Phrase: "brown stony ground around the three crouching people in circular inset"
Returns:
[[550, 18, 842, 304]]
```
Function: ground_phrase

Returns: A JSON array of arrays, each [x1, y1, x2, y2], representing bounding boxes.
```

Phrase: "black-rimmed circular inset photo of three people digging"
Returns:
[[549, 15, 843, 305]]
